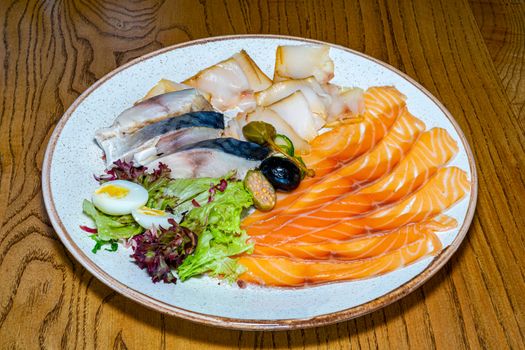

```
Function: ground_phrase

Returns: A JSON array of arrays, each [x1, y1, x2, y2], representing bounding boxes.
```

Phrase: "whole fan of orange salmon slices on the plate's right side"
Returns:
[[235, 87, 470, 287]]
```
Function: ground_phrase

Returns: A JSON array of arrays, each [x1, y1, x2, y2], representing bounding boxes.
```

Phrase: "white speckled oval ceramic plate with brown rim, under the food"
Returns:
[[42, 35, 477, 329]]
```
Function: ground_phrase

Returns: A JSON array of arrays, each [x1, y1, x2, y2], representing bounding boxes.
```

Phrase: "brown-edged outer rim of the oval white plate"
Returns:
[[42, 34, 478, 330]]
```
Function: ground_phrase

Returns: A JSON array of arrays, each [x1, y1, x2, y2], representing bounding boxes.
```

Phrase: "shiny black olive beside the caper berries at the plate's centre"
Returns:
[[260, 157, 301, 192]]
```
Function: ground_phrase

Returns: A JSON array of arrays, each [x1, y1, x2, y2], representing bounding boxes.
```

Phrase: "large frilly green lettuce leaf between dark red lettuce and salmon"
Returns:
[[177, 182, 253, 281]]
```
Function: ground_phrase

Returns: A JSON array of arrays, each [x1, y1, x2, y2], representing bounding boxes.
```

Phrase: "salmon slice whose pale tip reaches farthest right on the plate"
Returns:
[[252, 167, 470, 244]]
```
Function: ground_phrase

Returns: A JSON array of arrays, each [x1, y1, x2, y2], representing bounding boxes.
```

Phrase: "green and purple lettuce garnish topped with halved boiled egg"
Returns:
[[81, 160, 253, 283]]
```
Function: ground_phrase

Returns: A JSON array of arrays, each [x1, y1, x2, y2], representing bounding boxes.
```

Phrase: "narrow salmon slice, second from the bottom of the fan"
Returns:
[[252, 215, 457, 260]]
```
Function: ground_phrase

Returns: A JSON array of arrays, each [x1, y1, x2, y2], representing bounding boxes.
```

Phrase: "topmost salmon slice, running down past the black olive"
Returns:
[[243, 87, 406, 227]]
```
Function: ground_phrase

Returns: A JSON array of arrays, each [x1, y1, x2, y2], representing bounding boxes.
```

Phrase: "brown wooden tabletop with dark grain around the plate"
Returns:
[[0, 0, 525, 349]]
